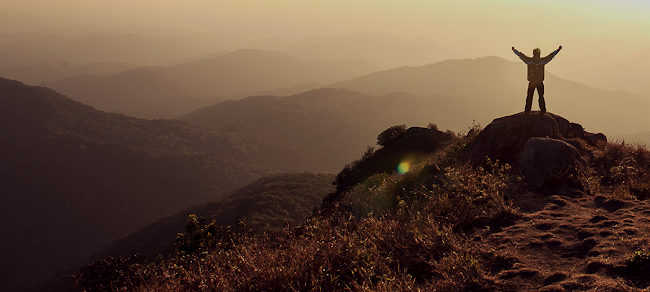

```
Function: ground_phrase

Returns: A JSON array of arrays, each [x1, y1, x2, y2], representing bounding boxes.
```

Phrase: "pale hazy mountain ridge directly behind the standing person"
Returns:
[[327, 57, 650, 133]]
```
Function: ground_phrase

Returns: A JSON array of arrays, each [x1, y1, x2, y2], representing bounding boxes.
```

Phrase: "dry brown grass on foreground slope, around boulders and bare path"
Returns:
[[77, 133, 650, 291]]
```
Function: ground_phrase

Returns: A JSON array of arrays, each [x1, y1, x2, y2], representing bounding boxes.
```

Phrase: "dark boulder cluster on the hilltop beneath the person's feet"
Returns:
[[462, 113, 607, 188]]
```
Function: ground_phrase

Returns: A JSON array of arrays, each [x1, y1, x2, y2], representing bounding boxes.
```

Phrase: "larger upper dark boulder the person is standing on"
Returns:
[[462, 113, 585, 166]]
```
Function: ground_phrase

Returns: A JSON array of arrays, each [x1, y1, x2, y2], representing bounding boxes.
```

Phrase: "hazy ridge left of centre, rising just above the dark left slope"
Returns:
[[38, 50, 375, 117]]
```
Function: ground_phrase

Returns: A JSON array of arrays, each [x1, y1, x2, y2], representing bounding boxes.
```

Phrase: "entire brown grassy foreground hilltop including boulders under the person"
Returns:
[[77, 114, 650, 292]]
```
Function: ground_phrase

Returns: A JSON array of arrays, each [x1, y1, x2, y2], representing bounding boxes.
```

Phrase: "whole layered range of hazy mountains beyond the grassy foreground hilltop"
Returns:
[[0, 36, 650, 290]]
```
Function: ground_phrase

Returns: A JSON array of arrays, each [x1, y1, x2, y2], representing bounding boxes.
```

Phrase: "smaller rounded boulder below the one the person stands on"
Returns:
[[515, 137, 586, 188]]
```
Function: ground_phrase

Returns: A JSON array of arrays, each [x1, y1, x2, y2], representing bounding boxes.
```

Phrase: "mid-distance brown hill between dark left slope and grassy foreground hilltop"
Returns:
[[180, 88, 480, 172]]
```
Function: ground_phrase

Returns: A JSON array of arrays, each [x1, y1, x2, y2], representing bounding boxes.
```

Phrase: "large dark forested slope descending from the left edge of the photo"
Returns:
[[0, 79, 270, 291]]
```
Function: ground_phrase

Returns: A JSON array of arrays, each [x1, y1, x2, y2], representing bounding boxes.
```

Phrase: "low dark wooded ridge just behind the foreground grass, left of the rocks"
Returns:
[[95, 173, 335, 259]]
